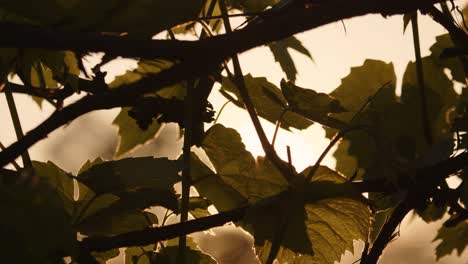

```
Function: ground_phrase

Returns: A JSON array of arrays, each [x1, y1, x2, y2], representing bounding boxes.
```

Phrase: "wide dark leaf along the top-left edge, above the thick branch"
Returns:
[[0, 0, 204, 37]]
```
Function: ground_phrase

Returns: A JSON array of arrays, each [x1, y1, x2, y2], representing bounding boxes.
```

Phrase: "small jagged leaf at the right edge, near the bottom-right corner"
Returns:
[[434, 220, 468, 260]]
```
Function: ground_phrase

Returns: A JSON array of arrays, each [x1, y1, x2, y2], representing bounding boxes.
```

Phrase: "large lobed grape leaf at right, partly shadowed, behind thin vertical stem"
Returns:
[[327, 57, 457, 179]]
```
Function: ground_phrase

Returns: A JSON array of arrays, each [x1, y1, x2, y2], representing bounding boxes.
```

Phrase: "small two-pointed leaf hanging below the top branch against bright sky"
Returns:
[[268, 36, 313, 81]]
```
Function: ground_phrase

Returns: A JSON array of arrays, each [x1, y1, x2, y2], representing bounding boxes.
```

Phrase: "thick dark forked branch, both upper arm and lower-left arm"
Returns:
[[0, 0, 441, 167]]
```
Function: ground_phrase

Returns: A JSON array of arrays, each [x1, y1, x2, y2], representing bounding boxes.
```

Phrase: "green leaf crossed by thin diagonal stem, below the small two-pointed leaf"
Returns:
[[221, 74, 312, 130]]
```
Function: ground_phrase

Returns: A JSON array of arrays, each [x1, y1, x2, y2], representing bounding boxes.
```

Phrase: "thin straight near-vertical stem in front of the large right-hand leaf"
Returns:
[[411, 11, 433, 146]]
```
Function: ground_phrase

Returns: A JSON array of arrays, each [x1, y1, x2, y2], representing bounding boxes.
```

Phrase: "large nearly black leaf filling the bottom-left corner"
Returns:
[[0, 175, 77, 263]]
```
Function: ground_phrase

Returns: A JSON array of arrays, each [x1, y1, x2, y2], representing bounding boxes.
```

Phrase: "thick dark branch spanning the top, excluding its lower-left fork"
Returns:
[[0, 0, 442, 59]]
